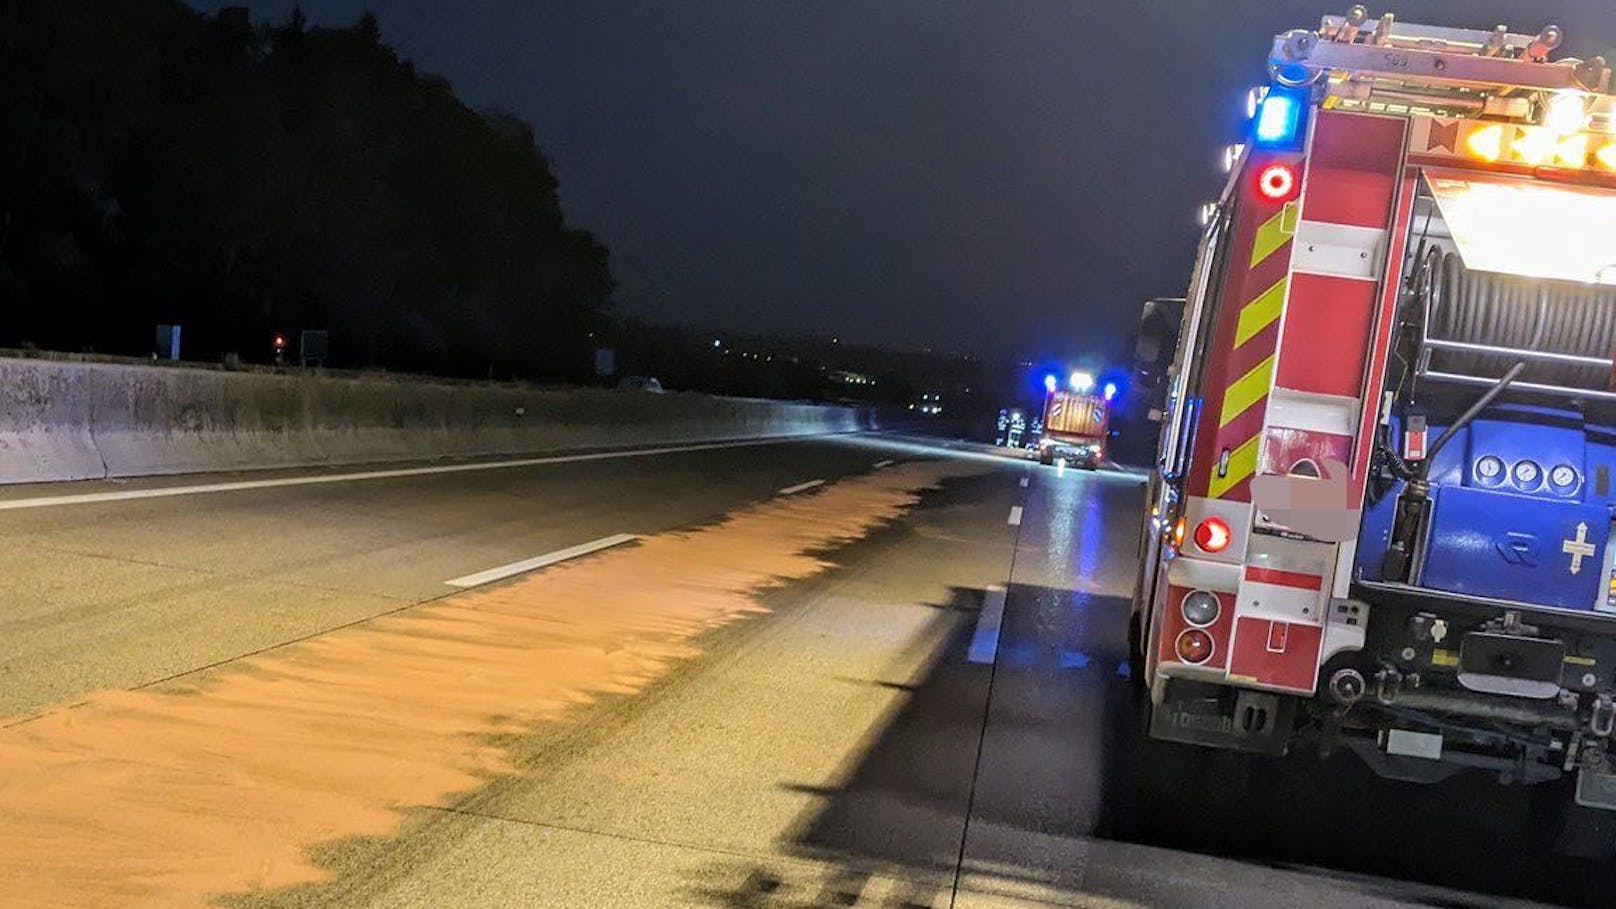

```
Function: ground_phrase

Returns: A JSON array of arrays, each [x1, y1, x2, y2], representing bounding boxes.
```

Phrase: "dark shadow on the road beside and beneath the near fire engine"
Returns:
[[692, 587, 1616, 909]]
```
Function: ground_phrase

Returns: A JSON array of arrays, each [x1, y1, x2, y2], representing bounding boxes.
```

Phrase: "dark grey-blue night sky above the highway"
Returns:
[[185, 0, 1616, 363]]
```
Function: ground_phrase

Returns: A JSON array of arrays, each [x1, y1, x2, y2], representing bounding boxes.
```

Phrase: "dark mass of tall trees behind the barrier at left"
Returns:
[[0, 0, 612, 378]]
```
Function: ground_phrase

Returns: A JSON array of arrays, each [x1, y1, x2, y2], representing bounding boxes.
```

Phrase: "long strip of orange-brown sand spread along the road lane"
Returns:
[[0, 463, 962, 909]]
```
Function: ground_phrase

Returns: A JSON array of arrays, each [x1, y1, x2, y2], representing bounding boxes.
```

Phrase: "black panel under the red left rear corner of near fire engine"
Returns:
[[1151, 678, 1296, 755]]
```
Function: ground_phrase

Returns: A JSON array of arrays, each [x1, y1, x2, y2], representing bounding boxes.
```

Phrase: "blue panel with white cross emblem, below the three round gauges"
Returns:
[[1419, 487, 1610, 611]]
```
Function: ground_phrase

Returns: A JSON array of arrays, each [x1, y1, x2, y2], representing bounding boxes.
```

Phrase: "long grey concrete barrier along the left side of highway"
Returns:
[[0, 359, 871, 484]]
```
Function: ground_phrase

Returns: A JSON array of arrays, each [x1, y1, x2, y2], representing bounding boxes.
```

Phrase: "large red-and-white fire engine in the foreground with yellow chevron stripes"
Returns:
[[1131, 6, 1616, 852]]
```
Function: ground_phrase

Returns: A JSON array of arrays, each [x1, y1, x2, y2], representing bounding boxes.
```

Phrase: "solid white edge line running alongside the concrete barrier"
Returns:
[[0, 435, 826, 511]]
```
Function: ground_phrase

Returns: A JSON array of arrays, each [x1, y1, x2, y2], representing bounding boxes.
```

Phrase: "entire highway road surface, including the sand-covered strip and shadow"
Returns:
[[0, 437, 1616, 909]]
